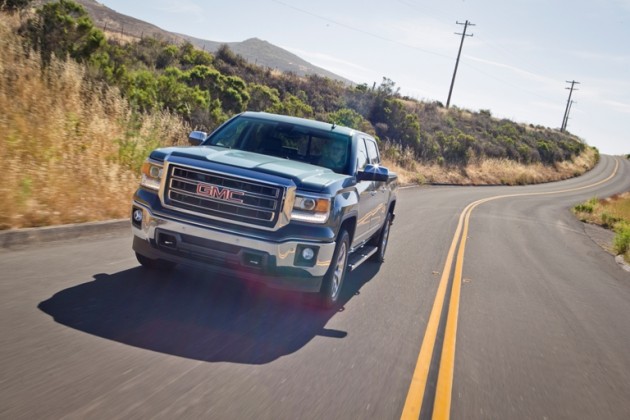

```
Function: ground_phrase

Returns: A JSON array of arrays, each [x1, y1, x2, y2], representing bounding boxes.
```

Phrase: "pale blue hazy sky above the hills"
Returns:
[[100, 0, 630, 154]]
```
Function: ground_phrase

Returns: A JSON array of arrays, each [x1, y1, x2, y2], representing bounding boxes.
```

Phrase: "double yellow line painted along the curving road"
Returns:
[[401, 159, 619, 420]]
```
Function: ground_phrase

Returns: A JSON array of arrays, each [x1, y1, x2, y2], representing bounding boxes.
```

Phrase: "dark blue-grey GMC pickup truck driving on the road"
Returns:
[[131, 112, 397, 307]]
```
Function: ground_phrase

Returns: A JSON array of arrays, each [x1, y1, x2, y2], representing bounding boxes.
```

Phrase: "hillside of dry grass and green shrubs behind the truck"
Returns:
[[0, 0, 599, 229]]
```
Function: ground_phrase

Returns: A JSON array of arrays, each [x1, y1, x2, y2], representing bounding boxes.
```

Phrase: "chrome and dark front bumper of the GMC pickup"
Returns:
[[132, 201, 335, 292]]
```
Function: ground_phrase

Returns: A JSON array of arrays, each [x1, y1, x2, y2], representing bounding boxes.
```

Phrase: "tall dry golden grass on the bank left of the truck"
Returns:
[[0, 15, 189, 229]]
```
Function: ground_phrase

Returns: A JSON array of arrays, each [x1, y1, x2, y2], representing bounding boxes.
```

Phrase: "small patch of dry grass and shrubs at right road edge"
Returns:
[[573, 192, 630, 263]]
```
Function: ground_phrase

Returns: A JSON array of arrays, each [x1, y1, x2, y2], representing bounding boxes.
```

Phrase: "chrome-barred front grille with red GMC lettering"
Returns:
[[164, 164, 284, 228]]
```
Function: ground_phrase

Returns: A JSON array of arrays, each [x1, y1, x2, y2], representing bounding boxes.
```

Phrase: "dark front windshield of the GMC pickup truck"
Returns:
[[203, 117, 350, 173]]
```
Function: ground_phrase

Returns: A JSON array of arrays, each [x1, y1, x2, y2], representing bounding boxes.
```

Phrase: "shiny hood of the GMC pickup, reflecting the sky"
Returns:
[[151, 146, 349, 191]]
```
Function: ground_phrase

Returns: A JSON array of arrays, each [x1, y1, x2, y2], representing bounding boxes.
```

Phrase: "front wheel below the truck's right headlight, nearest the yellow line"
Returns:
[[318, 230, 350, 309]]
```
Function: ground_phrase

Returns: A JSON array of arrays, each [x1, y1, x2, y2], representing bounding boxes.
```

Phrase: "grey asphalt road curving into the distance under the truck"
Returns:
[[0, 157, 630, 419]]
